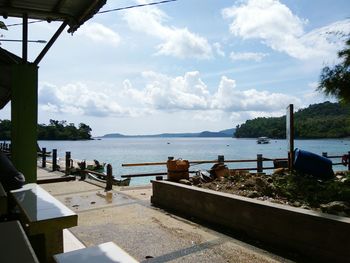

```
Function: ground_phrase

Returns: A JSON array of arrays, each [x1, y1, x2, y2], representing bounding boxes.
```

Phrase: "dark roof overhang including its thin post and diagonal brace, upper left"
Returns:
[[0, 0, 107, 109]]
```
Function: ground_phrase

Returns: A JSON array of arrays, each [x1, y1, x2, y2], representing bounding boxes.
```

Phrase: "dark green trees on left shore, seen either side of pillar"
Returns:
[[0, 120, 91, 140]]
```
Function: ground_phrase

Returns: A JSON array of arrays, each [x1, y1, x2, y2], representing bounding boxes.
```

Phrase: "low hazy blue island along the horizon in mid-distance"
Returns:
[[98, 128, 235, 138]]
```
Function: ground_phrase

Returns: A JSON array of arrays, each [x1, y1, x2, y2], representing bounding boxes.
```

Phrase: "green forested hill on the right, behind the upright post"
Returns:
[[235, 101, 350, 139]]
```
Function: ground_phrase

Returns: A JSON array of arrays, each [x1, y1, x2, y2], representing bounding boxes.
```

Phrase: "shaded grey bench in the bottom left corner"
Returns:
[[0, 221, 39, 263]]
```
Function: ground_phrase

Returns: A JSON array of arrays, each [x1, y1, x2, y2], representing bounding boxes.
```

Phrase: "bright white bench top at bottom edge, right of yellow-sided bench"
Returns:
[[54, 242, 138, 263]]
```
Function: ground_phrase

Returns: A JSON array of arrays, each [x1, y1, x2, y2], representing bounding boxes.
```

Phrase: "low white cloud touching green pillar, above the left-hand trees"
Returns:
[[39, 83, 131, 117]]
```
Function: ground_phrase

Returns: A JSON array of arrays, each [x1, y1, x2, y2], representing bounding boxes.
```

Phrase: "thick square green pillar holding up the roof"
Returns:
[[11, 63, 38, 183]]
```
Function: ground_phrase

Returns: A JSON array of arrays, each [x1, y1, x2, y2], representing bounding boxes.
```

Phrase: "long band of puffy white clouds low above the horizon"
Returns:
[[39, 71, 301, 121]]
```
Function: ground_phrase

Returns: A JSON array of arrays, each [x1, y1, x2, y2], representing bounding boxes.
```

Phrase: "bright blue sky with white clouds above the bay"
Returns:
[[0, 0, 350, 136]]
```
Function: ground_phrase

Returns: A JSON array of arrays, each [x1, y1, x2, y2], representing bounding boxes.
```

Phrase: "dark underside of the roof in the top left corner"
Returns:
[[0, 0, 106, 33]]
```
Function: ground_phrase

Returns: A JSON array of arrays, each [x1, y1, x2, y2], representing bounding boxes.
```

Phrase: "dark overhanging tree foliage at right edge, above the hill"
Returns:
[[317, 38, 350, 103]]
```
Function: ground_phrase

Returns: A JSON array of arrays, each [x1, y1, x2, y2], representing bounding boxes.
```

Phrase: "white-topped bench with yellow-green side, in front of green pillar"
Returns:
[[11, 184, 78, 262]]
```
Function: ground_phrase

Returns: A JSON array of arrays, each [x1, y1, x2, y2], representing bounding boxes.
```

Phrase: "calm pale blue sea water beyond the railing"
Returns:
[[39, 138, 350, 185]]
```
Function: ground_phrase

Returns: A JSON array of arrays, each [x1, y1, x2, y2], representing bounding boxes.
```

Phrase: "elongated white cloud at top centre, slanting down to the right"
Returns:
[[124, 2, 213, 59]]
